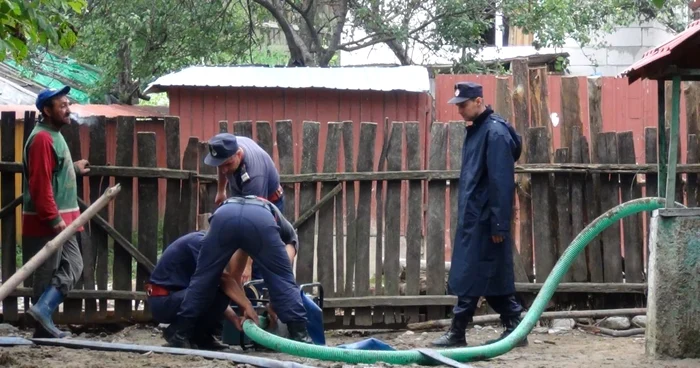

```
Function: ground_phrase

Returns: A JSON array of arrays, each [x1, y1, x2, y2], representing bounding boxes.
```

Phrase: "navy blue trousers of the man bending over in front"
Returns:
[[178, 202, 306, 323]]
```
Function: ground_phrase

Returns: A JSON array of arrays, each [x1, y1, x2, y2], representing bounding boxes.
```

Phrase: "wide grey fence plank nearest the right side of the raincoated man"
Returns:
[[527, 126, 557, 282]]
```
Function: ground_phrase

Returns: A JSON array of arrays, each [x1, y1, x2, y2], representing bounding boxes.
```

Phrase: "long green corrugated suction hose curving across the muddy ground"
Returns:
[[243, 197, 668, 365]]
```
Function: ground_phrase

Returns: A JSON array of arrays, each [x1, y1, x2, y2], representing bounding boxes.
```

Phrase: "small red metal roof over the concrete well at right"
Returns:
[[622, 20, 700, 83]]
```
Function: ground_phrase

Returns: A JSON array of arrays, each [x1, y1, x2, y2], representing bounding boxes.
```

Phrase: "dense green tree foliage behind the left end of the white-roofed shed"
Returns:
[[62, 0, 276, 103]]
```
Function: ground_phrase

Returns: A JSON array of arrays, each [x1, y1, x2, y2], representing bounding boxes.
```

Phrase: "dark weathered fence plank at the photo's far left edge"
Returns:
[[0, 111, 19, 322]]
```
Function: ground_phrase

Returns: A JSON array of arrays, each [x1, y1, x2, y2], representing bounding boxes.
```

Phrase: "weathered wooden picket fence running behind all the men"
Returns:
[[0, 79, 700, 327]]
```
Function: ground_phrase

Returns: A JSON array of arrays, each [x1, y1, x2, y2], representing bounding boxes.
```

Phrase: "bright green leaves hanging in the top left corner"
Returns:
[[0, 0, 87, 61]]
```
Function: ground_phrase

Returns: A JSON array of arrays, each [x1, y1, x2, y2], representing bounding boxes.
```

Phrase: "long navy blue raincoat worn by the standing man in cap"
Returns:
[[448, 108, 522, 297]]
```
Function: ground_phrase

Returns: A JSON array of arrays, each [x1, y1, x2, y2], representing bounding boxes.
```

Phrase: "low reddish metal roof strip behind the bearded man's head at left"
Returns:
[[0, 104, 168, 118]]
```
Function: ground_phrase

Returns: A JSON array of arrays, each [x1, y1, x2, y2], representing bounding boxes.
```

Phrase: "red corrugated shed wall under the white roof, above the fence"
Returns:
[[168, 87, 432, 171]]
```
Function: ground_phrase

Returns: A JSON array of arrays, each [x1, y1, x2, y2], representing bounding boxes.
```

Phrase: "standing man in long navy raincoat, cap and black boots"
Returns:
[[433, 82, 527, 347]]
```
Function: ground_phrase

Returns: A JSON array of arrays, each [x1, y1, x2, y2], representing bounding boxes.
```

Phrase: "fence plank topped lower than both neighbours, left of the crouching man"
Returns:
[[136, 132, 158, 311]]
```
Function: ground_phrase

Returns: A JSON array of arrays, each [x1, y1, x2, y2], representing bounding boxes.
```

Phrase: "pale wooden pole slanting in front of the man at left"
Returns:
[[0, 184, 121, 301]]
